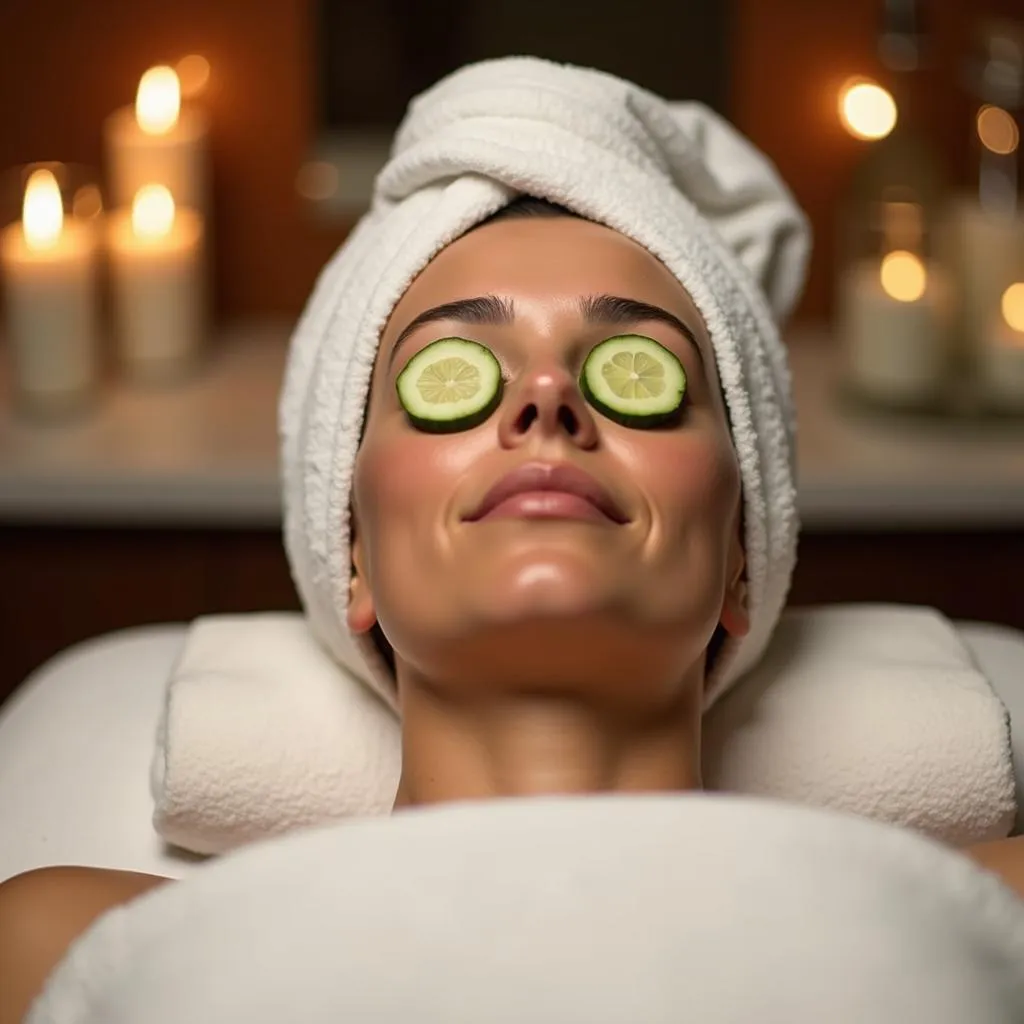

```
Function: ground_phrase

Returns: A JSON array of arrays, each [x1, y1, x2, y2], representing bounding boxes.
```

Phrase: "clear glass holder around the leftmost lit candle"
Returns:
[[0, 163, 103, 412]]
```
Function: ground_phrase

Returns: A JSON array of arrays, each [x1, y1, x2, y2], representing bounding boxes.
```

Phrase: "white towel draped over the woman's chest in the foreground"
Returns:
[[27, 795, 1024, 1024]]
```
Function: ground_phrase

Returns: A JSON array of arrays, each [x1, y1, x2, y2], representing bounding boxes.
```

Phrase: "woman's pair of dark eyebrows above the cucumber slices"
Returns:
[[388, 295, 703, 366]]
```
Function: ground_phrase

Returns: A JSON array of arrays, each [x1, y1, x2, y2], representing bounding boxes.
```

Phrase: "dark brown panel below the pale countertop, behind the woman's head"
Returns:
[[0, 526, 1024, 700]]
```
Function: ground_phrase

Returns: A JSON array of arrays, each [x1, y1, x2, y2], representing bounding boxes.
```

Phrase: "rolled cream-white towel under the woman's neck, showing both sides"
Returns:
[[153, 605, 1016, 853]]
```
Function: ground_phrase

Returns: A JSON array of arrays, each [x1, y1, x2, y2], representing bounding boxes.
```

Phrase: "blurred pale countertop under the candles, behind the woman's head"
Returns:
[[0, 323, 1024, 530]]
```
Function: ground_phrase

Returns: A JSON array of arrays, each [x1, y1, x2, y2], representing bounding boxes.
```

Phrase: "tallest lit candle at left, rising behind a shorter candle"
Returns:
[[103, 66, 209, 213]]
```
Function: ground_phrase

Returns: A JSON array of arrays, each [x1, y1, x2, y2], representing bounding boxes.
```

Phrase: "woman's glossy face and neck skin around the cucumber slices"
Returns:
[[348, 218, 749, 805]]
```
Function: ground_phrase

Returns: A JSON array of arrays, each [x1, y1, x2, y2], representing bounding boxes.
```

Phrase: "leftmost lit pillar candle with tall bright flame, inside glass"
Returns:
[[0, 168, 98, 407]]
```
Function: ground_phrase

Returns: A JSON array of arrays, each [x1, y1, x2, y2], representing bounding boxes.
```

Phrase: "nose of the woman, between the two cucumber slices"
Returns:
[[498, 364, 598, 449]]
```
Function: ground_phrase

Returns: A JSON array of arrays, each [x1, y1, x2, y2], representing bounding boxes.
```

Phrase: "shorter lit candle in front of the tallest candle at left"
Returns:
[[108, 184, 204, 379]]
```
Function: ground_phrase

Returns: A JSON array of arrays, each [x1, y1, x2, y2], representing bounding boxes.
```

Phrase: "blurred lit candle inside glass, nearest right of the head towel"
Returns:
[[840, 250, 948, 407]]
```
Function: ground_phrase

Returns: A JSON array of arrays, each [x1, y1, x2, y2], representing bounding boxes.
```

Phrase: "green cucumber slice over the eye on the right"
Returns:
[[580, 334, 686, 427]]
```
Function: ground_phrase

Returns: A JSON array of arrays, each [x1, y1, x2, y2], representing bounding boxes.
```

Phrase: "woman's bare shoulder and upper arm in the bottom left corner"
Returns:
[[0, 867, 169, 1024]]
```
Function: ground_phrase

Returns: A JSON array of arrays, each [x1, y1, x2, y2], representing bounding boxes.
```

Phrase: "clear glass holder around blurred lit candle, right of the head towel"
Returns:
[[838, 189, 952, 410]]
